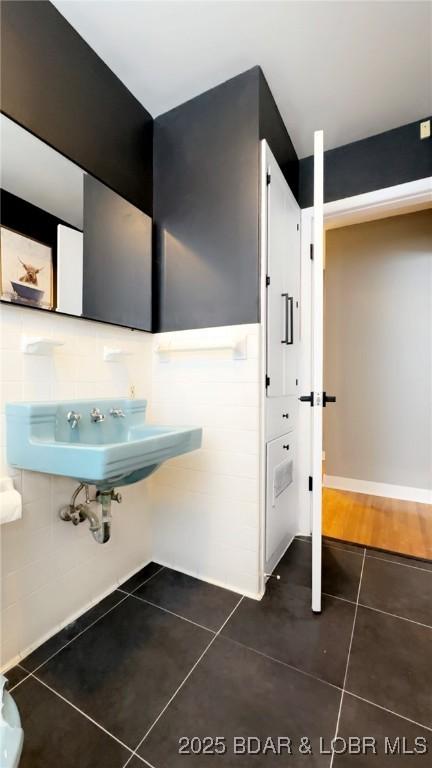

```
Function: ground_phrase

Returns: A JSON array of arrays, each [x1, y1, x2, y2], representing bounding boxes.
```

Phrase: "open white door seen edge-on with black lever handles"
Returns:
[[312, 131, 324, 613]]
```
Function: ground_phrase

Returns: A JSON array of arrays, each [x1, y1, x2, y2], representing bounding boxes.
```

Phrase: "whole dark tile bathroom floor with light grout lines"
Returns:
[[7, 537, 432, 768]]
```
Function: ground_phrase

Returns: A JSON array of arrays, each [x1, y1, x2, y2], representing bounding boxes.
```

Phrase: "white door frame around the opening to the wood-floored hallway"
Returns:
[[298, 176, 432, 536]]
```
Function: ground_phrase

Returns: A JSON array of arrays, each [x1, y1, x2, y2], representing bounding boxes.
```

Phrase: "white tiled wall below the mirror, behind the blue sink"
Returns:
[[0, 306, 152, 665]]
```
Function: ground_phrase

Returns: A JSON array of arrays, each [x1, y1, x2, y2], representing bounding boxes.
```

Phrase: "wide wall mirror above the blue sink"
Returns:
[[0, 114, 152, 331]]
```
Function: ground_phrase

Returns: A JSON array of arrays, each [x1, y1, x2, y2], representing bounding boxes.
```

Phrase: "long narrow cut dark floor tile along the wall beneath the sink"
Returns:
[[21, 590, 125, 672]]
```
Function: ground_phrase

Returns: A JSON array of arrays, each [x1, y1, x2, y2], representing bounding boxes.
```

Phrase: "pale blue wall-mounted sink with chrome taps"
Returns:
[[6, 398, 202, 490]]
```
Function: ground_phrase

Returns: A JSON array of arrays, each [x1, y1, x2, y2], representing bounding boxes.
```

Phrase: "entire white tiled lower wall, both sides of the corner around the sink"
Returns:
[[0, 306, 261, 666]]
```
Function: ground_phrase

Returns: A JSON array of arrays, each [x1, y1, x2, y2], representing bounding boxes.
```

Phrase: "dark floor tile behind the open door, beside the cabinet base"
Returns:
[[275, 540, 363, 602]]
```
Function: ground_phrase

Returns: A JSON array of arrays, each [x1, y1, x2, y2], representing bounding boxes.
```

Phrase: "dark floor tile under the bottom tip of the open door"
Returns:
[[222, 582, 355, 686]]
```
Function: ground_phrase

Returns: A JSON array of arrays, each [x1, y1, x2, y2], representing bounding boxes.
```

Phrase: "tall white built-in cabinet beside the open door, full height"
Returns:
[[261, 142, 300, 574]]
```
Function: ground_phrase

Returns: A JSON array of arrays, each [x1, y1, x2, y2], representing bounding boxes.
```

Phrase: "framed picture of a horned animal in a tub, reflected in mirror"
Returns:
[[0, 226, 54, 309]]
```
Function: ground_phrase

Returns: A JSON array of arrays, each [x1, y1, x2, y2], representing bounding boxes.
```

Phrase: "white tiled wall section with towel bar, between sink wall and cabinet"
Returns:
[[150, 325, 261, 597]]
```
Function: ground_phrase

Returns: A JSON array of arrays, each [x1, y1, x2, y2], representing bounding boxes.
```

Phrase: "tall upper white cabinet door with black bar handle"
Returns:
[[263, 143, 300, 397]]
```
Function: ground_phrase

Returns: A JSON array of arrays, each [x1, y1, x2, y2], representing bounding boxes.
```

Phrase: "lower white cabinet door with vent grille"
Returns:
[[265, 431, 297, 572]]
